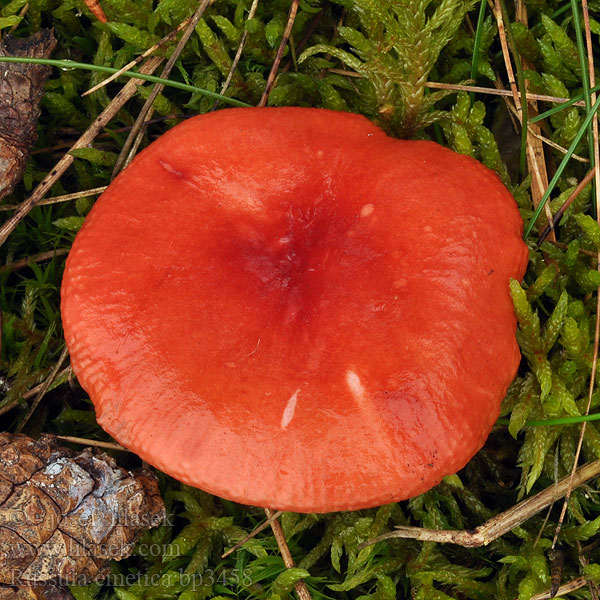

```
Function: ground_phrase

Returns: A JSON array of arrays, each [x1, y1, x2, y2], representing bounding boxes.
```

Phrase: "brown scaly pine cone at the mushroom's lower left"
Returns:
[[0, 433, 165, 600]]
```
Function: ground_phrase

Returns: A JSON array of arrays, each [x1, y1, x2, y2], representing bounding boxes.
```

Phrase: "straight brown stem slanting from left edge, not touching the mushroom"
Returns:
[[0, 57, 163, 246]]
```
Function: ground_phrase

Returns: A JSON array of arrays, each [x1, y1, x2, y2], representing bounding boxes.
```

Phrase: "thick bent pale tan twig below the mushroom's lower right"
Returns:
[[358, 460, 600, 549]]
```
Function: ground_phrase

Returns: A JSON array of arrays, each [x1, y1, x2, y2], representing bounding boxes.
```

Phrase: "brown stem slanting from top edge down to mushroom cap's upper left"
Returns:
[[112, 0, 214, 178]]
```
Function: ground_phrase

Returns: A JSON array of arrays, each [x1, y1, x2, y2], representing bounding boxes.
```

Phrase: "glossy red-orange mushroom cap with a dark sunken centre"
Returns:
[[62, 108, 527, 512]]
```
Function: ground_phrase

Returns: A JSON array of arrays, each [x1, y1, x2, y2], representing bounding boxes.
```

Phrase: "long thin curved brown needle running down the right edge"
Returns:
[[552, 0, 600, 548]]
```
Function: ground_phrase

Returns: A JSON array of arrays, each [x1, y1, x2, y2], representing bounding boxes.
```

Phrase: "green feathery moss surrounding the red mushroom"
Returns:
[[0, 0, 600, 600]]
